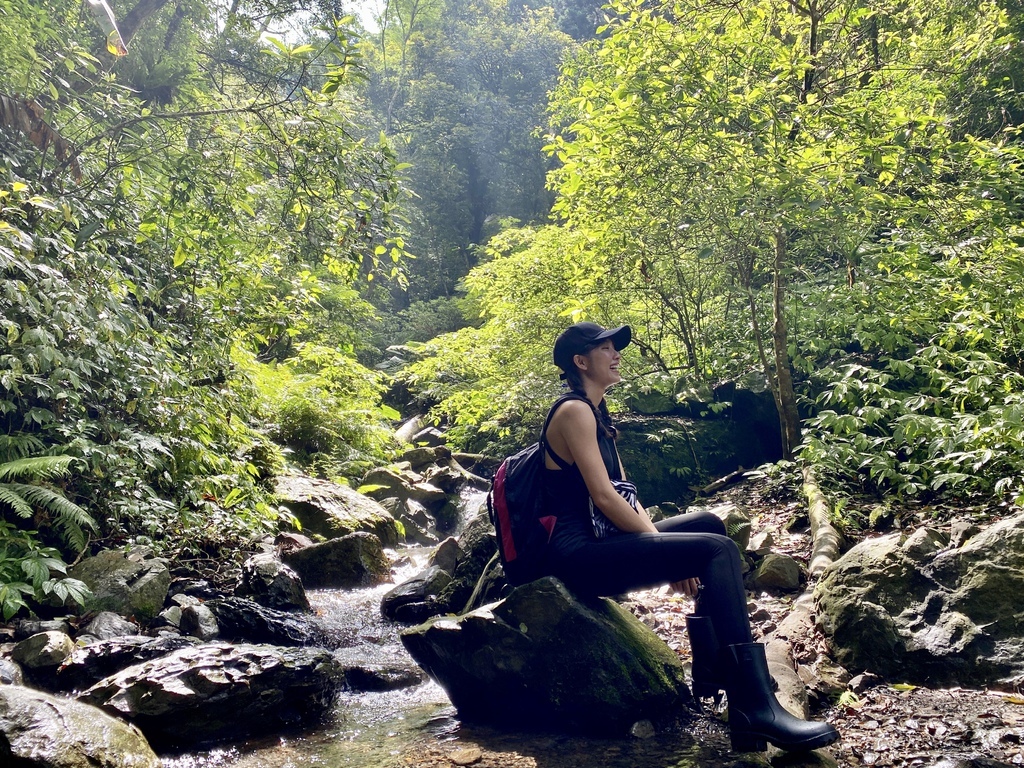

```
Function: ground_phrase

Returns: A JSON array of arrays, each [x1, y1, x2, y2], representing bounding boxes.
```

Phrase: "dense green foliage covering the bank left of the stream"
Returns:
[[0, 0, 402, 615]]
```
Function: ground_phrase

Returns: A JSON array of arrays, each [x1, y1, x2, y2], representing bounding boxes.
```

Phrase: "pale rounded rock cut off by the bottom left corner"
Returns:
[[0, 685, 161, 768]]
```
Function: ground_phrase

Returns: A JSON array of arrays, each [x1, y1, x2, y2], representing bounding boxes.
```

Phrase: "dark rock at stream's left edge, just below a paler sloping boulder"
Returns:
[[285, 532, 391, 589]]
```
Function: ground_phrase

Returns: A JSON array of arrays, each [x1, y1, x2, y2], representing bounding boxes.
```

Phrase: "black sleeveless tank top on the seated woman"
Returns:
[[543, 395, 622, 557]]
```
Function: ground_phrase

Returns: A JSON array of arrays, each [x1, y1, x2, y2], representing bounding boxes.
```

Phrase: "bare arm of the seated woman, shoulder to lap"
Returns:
[[548, 400, 657, 532]]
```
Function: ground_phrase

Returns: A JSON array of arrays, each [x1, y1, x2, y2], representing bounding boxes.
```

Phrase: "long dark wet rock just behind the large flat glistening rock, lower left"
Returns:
[[55, 635, 199, 691]]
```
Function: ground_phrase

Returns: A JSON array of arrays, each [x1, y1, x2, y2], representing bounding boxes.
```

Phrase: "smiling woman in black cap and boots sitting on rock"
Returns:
[[542, 323, 839, 752]]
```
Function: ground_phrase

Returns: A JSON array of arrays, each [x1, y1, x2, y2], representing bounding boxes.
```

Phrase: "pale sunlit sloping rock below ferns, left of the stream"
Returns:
[[276, 475, 398, 548]]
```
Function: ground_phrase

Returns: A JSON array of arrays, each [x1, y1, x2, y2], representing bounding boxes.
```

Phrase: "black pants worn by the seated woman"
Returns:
[[552, 512, 752, 645]]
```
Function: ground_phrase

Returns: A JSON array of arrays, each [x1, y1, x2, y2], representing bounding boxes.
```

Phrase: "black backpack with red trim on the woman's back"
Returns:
[[487, 392, 589, 587]]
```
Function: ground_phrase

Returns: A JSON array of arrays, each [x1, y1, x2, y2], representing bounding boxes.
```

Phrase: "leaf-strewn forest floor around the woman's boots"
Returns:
[[389, 478, 1024, 768]]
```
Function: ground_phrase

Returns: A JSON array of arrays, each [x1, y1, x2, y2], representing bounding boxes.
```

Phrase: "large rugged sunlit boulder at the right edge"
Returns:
[[814, 515, 1024, 685]]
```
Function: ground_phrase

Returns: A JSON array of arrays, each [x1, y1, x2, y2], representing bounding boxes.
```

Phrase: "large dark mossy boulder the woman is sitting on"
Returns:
[[401, 578, 688, 735]]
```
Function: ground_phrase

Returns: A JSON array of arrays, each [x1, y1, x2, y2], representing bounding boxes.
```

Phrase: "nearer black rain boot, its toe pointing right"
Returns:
[[722, 643, 839, 752]]
